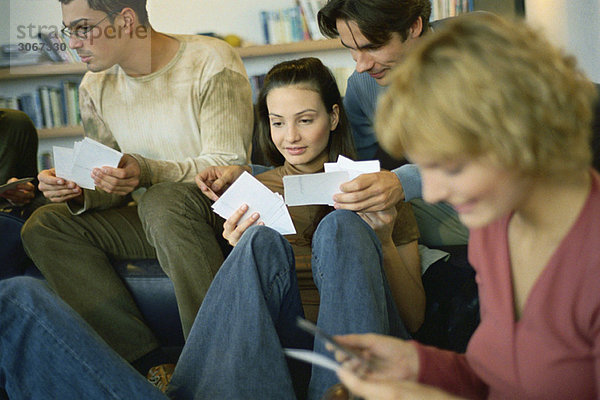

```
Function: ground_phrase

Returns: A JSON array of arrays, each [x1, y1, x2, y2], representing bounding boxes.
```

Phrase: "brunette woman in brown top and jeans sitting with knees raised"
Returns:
[[3, 58, 425, 399]]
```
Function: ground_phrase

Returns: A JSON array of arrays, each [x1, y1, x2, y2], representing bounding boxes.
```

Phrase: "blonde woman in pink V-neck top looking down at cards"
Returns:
[[328, 15, 600, 399]]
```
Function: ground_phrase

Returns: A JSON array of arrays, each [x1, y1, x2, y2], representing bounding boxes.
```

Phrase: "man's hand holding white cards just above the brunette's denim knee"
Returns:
[[333, 171, 404, 212]]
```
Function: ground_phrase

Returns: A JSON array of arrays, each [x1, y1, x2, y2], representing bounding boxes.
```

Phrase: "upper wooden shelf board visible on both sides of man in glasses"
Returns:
[[0, 39, 344, 81]]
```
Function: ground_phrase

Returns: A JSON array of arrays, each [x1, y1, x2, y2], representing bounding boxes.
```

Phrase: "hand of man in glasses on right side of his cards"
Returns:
[[92, 154, 142, 196]]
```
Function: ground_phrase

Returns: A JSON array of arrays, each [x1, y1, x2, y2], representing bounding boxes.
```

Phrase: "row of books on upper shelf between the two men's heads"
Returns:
[[260, 0, 325, 44]]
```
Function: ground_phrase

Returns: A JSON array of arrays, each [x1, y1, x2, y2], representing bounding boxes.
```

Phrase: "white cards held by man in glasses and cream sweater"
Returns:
[[53, 138, 123, 190]]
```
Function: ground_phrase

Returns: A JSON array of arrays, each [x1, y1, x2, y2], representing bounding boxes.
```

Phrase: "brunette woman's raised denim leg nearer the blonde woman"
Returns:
[[309, 210, 410, 399]]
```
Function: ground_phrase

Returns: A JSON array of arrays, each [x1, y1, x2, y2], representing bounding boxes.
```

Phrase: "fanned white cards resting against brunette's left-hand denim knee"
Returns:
[[212, 172, 296, 235]]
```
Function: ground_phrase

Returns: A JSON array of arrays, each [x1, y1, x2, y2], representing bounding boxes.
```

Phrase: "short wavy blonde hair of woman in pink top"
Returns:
[[376, 14, 596, 175]]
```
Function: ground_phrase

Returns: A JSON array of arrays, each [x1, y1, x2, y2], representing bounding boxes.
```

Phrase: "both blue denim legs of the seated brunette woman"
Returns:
[[168, 211, 408, 399]]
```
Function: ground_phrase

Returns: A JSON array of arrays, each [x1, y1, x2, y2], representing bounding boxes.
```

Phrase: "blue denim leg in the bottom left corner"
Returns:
[[0, 277, 166, 400]]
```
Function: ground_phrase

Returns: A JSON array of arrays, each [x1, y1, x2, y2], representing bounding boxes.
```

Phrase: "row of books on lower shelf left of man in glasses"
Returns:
[[0, 81, 81, 129]]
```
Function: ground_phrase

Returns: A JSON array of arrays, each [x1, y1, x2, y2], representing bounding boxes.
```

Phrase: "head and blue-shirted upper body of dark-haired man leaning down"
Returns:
[[318, 0, 431, 169]]
